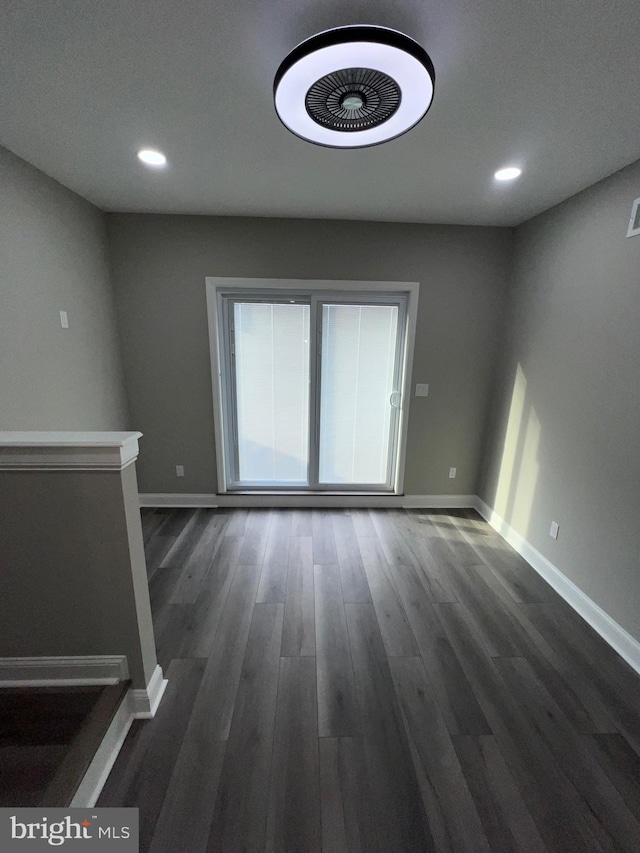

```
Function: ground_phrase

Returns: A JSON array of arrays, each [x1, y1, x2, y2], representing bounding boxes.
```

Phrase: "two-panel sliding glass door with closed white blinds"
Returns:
[[220, 291, 406, 491]]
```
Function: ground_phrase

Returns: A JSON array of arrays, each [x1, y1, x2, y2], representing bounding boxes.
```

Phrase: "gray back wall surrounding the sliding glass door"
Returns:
[[107, 214, 512, 494]]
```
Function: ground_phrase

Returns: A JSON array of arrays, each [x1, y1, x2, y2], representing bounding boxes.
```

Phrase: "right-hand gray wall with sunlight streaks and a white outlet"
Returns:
[[479, 162, 640, 639]]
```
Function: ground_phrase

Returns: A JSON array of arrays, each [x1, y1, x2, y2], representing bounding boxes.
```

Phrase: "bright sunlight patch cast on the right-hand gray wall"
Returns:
[[493, 364, 541, 539]]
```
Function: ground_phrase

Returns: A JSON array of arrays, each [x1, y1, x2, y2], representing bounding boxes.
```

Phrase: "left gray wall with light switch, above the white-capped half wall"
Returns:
[[0, 148, 128, 430]]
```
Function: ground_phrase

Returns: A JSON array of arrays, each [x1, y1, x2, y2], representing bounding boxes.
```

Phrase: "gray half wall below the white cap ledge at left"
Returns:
[[0, 464, 156, 689]]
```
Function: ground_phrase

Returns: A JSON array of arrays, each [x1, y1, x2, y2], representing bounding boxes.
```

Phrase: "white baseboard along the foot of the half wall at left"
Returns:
[[0, 655, 129, 687]]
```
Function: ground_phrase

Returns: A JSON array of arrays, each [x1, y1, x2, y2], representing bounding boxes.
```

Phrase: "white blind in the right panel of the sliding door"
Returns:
[[319, 304, 398, 485]]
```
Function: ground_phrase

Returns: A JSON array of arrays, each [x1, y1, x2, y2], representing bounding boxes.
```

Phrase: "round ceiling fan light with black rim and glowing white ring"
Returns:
[[273, 24, 435, 148]]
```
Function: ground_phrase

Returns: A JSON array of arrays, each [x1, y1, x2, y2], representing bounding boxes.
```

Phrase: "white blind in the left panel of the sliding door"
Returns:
[[233, 302, 310, 484]]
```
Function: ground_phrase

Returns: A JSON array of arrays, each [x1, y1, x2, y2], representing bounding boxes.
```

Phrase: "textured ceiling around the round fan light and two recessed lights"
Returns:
[[0, 0, 640, 225]]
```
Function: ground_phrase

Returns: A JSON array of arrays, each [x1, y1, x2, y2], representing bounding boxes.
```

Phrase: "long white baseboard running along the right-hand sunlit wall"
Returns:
[[475, 498, 640, 674]]
